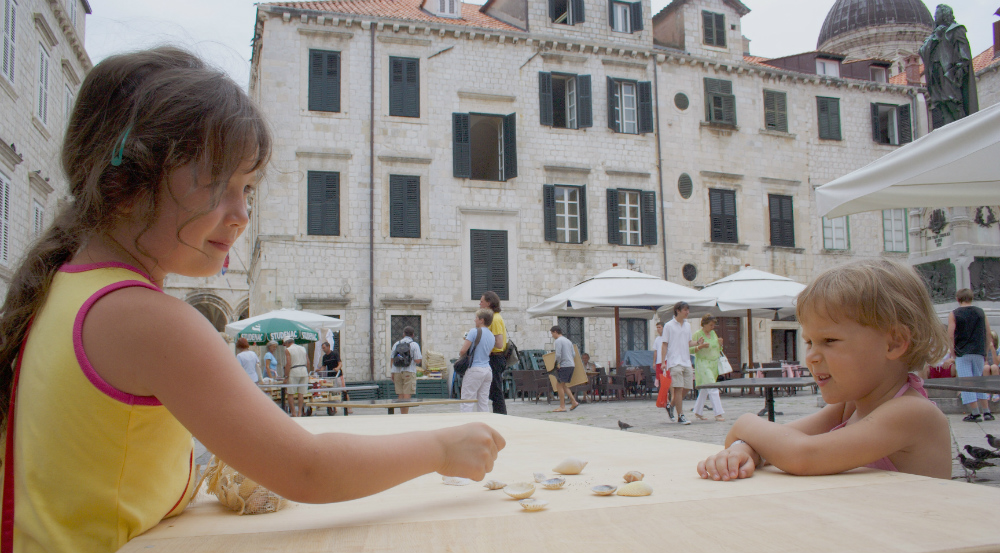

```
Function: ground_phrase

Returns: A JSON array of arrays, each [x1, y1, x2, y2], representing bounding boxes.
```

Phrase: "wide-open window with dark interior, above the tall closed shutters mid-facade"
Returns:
[[451, 113, 517, 181]]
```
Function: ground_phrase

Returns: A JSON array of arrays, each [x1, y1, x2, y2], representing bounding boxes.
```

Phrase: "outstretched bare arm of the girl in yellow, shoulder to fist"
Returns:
[[83, 288, 505, 503]]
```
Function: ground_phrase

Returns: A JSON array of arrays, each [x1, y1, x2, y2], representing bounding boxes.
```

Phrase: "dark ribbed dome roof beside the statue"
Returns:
[[816, 0, 934, 49]]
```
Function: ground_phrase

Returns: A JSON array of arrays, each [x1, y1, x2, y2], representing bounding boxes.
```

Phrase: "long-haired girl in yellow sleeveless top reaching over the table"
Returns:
[[0, 48, 504, 551]]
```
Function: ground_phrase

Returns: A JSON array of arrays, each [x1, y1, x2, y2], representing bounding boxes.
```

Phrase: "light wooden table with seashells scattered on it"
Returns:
[[121, 413, 1000, 553]]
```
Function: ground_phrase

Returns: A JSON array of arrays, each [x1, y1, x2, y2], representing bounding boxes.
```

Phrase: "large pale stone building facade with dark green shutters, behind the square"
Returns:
[[246, 0, 940, 379]]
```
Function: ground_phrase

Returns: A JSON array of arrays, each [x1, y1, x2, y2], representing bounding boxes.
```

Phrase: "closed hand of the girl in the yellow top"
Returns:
[[437, 422, 507, 480]]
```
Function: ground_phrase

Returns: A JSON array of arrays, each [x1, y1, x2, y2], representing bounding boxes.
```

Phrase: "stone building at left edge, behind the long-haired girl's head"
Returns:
[[0, 0, 91, 296]]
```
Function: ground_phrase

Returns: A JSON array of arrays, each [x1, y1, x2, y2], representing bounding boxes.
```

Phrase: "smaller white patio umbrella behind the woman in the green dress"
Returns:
[[701, 266, 806, 367]]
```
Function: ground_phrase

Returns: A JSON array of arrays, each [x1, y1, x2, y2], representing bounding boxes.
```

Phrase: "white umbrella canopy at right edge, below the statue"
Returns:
[[816, 104, 1000, 217]]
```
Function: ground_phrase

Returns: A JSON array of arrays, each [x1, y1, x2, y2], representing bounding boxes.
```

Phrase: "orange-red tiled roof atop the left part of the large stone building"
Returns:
[[262, 0, 520, 31]]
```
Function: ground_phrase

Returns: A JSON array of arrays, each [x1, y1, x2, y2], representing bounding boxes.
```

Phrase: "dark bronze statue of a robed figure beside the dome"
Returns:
[[920, 4, 979, 128]]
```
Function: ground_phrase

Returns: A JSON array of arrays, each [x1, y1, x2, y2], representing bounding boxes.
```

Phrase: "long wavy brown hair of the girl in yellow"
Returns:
[[0, 47, 271, 425]]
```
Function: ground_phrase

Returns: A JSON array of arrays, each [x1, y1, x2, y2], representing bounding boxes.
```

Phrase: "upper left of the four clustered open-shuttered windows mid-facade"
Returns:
[[538, 72, 594, 129]]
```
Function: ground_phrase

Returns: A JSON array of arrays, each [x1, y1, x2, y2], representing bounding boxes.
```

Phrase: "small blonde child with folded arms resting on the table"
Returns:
[[698, 260, 951, 480]]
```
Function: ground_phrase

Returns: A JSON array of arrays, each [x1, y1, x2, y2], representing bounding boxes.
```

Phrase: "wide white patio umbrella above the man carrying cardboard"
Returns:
[[528, 269, 715, 364]]
